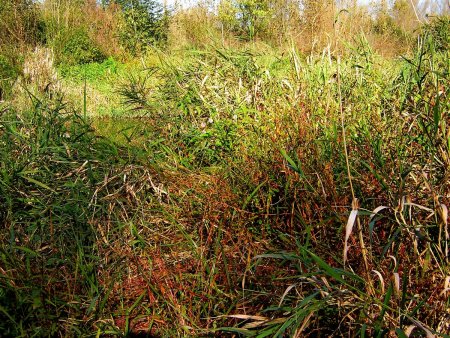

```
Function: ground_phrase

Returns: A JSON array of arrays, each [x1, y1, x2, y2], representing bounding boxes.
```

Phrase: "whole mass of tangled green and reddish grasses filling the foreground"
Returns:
[[0, 22, 450, 337]]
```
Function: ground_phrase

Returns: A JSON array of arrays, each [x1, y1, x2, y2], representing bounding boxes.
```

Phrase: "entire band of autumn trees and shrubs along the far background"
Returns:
[[0, 0, 431, 64]]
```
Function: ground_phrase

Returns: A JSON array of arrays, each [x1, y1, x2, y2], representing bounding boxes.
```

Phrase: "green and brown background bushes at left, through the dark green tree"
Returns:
[[0, 0, 170, 100]]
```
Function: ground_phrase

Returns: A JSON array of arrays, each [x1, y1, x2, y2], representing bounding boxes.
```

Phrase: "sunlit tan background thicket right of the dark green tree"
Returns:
[[175, 0, 433, 54]]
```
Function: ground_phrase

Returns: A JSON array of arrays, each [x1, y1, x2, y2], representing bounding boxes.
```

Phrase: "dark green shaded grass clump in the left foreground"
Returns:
[[0, 100, 147, 337]]
